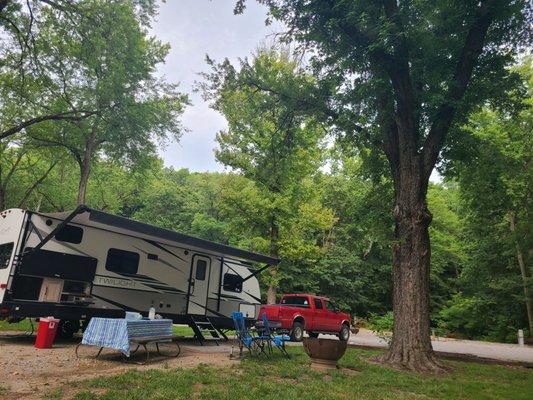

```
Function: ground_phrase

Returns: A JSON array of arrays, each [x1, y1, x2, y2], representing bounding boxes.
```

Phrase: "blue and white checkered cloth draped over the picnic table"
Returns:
[[81, 318, 172, 357]]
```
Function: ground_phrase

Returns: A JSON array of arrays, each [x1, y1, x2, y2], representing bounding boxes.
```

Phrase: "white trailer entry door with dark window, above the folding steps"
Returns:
[[187, 254, 211, 315]]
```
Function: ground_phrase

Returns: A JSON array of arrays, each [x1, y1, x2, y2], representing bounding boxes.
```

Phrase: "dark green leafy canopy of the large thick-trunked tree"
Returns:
[[246, 0, 530, 145]]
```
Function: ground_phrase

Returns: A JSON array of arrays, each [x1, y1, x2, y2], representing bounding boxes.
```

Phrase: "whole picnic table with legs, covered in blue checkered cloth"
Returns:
[[76, 317, 180, 362]]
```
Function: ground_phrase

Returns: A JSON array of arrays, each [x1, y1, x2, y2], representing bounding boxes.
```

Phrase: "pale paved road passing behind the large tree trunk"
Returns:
[[338, 329, 533, 363]]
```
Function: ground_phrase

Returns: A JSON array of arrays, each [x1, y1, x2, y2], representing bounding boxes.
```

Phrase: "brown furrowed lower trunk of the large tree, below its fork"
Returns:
[[383, 160, 442, 371]]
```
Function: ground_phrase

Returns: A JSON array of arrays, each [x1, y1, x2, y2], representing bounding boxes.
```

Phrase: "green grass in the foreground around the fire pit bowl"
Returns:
[[59, 347, 533, 400]]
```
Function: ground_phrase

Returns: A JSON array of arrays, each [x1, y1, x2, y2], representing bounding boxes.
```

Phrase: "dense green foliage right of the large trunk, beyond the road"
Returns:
[[434, 60, 533, 342]]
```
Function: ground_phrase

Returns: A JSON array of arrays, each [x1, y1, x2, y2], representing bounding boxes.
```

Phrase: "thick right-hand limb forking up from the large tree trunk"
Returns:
[[422, 0, 493, 179]]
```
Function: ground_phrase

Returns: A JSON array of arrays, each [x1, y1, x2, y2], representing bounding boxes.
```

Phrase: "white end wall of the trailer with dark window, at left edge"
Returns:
[[0, 209, 25, 303]]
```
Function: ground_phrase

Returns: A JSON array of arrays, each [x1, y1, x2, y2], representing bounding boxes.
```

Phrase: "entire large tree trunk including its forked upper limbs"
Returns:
[[370, 0, 490, 371]]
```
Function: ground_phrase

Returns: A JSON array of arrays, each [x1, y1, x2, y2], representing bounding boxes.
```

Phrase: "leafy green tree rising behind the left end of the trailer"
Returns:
[[0, 0, 187, 202]]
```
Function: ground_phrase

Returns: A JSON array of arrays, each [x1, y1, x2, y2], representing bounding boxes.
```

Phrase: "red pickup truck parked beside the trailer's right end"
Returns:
[[258, 294, 350, 342]]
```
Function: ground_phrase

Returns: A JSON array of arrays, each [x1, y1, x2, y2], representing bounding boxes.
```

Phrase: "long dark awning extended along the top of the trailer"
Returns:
[[41, 206, 279, 265]]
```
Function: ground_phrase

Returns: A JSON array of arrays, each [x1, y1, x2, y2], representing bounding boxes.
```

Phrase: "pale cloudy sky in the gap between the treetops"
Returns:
[[148, 0, 276, 171]]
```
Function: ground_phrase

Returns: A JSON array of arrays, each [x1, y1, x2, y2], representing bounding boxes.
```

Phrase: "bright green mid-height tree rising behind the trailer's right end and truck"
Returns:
[[200, 49, 335, 296]]
